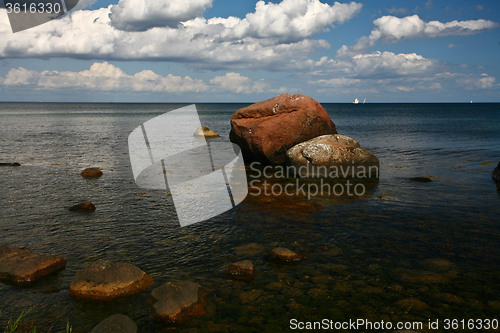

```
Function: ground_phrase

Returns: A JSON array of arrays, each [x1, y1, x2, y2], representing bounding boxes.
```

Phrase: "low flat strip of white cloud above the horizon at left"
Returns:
[[0, 62, 286, 94]]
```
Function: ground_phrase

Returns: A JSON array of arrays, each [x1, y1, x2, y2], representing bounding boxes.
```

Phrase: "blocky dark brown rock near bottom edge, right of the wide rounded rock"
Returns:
[[151, 281, 206, 323]]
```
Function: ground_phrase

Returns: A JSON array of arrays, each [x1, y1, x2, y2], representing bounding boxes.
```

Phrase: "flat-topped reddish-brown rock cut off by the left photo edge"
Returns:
[[0, 245, 66, 286]]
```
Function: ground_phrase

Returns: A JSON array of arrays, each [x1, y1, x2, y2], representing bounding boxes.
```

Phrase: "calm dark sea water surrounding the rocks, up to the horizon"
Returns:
[[0, 103, 500, 332]]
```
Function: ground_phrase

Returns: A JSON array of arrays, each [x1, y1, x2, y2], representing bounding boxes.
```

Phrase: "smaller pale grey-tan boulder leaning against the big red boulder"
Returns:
[[287, 134, 380, 178]]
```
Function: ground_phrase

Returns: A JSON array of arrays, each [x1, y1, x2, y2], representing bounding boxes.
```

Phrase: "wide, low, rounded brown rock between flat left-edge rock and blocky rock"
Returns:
[[69, 260, 153, 300]]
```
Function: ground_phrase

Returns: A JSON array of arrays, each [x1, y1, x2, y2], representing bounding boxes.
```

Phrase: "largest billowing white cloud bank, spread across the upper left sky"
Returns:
[[0, 0, 361, 70]]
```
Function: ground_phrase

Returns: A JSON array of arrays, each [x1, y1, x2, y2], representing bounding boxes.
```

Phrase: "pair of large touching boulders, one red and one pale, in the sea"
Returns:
[[230, 94, 380, 178]]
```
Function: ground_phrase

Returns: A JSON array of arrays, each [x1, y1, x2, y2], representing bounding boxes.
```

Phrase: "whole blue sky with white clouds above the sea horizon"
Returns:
[[0, 0, 500, 103]]
